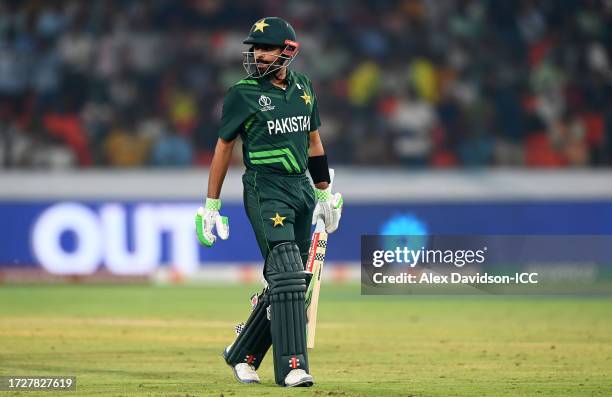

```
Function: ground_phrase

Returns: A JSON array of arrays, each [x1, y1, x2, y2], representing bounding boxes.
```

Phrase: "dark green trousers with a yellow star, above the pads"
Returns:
[[242, 170, 316, 263]]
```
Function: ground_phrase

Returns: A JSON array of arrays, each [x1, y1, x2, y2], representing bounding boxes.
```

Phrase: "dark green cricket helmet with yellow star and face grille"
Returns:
[[242, 17, 300, 78]]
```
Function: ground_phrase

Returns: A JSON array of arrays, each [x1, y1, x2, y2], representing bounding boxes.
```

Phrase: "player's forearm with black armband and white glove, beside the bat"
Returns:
[[308, 129, 344, 233]]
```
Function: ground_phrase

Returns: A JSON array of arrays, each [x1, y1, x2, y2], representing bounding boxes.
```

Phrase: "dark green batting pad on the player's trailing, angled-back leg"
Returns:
[[224, 290, 272, 369]]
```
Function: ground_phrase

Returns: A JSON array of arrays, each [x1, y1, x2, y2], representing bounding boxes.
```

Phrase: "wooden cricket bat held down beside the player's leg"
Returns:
[[306, 169, 334, 349]]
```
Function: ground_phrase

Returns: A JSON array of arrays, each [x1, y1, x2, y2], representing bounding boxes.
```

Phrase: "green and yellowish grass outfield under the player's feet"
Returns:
[[0, 285, 612, 397]]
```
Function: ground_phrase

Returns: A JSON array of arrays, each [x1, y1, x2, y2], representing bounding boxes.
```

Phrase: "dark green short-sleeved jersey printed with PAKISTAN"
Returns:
[[219, 70, 321, 174]]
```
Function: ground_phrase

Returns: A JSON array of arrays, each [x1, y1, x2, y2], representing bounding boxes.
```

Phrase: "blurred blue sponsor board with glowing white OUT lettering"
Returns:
[[0, 198, 612, 274]]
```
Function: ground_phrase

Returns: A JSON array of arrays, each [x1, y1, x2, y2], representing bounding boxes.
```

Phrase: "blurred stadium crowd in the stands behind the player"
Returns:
[[0, 0, 612, 168]]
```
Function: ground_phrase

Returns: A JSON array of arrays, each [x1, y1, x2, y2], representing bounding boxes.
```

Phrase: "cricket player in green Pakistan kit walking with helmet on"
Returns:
[[196, 17, 342, 386]]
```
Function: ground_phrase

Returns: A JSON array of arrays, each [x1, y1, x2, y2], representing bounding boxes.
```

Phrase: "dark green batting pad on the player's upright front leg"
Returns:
[[264, 242, 309, 386]]
